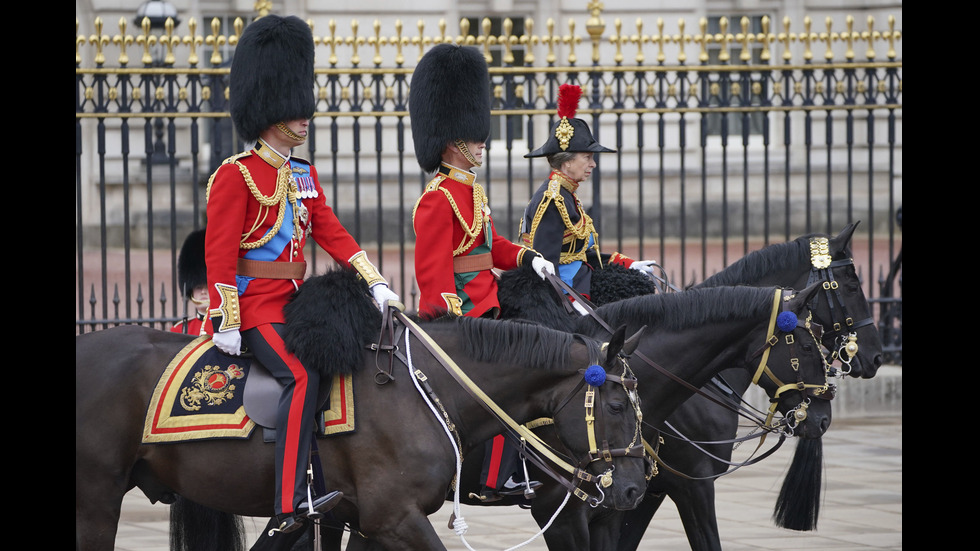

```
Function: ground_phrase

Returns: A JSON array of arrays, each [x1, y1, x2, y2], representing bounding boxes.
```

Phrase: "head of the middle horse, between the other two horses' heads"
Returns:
[[747, 283, 836, 438]]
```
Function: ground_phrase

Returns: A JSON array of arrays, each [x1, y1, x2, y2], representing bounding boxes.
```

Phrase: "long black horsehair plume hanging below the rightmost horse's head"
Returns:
[[772, 438, 823, 531]]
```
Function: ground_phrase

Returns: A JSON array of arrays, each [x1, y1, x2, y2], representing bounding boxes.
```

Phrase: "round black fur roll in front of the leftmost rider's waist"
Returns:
[[283, 269, 381, 375]]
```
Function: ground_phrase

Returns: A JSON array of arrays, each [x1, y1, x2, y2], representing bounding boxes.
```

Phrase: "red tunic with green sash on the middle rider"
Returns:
[[412, 164, 527, 317]]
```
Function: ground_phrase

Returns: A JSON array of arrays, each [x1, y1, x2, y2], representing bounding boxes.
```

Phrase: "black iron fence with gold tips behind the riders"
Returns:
[[75, 14, 902, 363]]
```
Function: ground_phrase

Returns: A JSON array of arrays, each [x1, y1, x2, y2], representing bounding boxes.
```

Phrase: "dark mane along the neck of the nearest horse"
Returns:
[[448, 318, 600, 369]]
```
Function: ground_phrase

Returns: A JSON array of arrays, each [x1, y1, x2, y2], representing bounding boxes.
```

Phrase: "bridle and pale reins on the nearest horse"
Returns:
[[376, 310, 645, 507]]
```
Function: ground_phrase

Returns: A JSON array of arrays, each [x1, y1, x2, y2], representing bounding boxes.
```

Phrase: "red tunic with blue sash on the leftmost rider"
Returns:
[[205, 140, 361, 331]]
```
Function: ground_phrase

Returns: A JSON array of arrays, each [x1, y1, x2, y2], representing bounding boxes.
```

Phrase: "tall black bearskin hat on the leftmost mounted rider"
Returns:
[[229, 15, 316, 142]]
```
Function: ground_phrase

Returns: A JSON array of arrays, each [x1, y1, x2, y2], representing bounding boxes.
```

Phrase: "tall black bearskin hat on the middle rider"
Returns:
[[408, 44, 490, 172]]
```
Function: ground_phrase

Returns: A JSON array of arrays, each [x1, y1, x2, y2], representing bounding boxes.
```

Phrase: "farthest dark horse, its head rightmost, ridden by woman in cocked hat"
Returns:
[[616, 222, 883, 551]]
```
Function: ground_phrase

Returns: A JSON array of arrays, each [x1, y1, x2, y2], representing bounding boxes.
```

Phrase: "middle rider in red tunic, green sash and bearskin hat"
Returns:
[[408, 44, 554, 501]]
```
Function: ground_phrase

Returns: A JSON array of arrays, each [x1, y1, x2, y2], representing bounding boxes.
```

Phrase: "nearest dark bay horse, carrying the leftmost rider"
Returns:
[[75, 271, 648, 551]]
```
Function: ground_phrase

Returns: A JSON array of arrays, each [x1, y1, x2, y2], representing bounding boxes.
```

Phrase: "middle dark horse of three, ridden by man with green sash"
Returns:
[[464, 280, 831, 550]]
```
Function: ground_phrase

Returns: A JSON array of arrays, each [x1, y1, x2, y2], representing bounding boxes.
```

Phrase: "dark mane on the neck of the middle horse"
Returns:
[[576, 286, 776, 334]]
